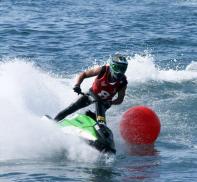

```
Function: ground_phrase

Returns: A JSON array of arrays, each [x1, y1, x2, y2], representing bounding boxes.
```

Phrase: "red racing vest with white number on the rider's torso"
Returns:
[[91, 66, 120, 100]]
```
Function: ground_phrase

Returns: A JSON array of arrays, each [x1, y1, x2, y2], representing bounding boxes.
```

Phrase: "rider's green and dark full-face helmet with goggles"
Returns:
[[110, 54, 128, 78]]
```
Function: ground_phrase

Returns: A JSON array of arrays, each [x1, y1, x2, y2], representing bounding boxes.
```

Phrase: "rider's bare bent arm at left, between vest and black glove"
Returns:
[[75, 67, 102, 86]]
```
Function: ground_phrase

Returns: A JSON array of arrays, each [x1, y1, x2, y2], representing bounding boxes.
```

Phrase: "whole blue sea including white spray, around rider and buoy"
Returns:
[[0, 0, 197, 182]]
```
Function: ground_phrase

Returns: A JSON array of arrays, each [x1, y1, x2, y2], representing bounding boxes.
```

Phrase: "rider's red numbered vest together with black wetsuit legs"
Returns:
[[54, 65, 127, 121]]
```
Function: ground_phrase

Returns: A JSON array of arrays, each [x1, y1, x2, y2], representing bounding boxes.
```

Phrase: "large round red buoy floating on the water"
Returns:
[[120, 106, 161, 144]]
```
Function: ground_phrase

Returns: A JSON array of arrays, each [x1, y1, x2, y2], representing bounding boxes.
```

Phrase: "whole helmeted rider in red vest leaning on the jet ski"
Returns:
[[54, 54, 128, 124]]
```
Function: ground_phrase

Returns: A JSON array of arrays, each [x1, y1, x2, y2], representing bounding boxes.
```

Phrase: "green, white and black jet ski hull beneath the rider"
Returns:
[[58, 114, 116, 154]]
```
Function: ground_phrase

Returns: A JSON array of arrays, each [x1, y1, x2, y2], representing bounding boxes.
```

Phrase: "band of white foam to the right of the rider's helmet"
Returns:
[[126, 54, 197, 83]]
